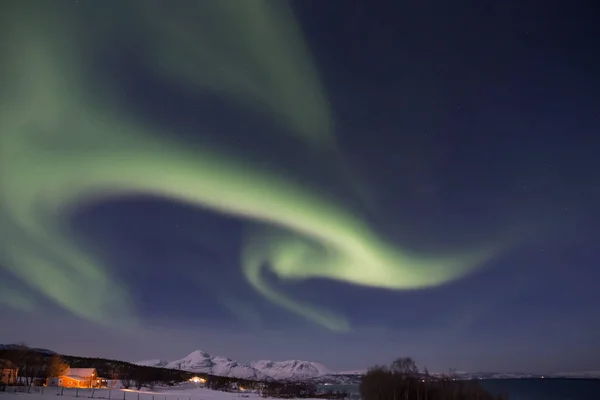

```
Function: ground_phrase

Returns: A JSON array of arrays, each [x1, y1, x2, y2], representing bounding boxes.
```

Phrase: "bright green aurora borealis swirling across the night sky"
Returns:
[[2, 2, 491, 329]]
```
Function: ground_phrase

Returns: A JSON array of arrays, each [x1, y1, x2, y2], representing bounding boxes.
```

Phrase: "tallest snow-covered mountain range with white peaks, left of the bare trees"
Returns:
[[136, 350, 332, 380]]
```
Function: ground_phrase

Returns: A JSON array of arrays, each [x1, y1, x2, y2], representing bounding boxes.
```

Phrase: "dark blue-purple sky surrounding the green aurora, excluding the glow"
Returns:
[[0, 0, 600, 372]]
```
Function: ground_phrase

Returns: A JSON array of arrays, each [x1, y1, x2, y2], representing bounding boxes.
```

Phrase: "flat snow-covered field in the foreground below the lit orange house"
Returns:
[[0, 386, 324, 400]]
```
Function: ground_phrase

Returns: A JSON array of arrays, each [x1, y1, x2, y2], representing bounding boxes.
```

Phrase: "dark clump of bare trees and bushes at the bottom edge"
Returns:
[[360, 358, 507, 400]]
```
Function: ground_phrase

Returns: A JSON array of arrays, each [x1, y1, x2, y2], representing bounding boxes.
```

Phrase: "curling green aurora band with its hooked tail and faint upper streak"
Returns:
[[0, 0, 494, 330]]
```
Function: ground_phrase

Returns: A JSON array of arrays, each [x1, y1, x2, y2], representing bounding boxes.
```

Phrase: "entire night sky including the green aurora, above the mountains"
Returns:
[[0, 0, 600, 373]]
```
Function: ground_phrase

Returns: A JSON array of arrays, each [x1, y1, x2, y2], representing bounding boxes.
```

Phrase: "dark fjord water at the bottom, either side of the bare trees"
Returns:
[[320, 379, 600, 400]]
